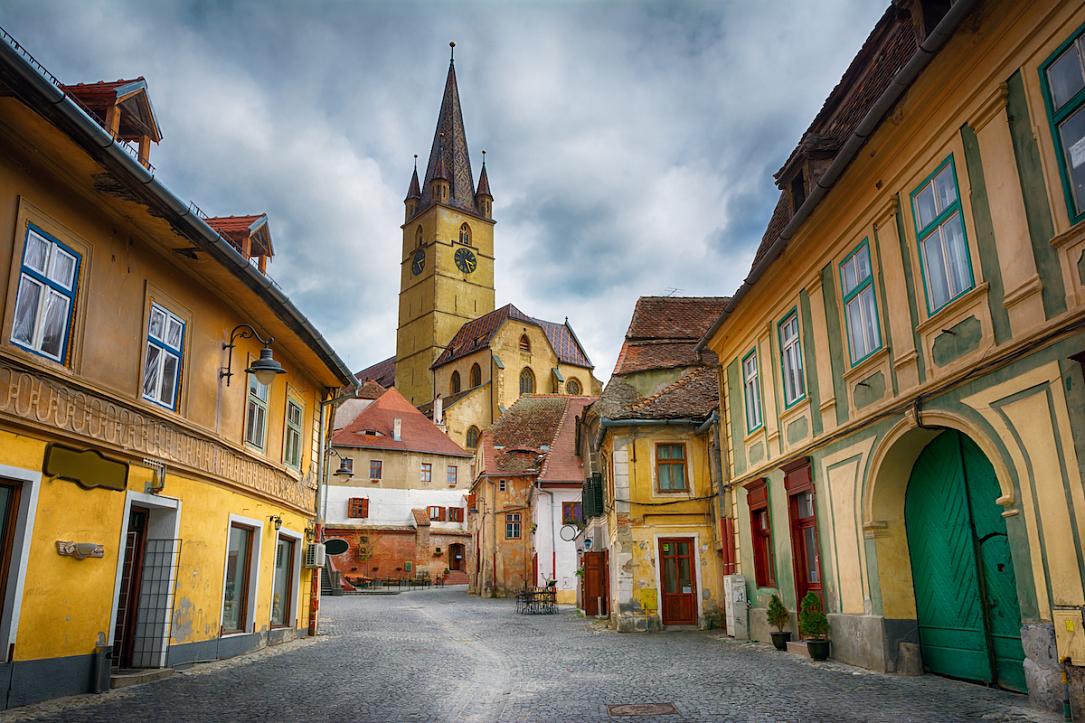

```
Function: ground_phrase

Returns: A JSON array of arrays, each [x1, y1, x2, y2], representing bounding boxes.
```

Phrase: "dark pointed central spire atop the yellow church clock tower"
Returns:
[[417, 42, 481, 215]]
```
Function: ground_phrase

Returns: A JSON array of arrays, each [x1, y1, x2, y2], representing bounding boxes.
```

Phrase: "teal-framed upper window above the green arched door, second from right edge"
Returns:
[[911, 155, 974, 314]]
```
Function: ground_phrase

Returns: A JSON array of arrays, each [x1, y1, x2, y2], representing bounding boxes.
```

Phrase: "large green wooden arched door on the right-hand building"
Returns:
[[904, 430, 1026, 692]]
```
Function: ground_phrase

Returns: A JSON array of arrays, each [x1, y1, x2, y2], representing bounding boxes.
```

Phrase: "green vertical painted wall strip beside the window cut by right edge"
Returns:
[[1006, 71, 1073, 318]]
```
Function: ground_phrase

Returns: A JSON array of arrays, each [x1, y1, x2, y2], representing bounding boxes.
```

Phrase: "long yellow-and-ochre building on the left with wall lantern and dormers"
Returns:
[[0, 28, 352, 706]]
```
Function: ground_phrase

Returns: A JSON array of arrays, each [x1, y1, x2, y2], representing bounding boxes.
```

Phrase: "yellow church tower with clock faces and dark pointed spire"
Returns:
[[395, 42, 494, 405]]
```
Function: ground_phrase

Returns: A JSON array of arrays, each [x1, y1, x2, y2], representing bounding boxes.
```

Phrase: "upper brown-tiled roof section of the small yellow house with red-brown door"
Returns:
[[614, 296, 727, 376]]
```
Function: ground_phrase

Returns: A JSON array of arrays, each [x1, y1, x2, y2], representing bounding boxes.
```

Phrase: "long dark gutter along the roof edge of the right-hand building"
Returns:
[[695, 0, 978, 351]]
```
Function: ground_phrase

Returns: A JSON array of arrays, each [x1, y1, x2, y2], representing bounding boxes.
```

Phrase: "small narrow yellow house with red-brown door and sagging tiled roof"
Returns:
[[577, 296, 726, 632]]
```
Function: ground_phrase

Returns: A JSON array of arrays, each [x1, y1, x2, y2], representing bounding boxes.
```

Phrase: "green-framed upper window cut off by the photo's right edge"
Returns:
[[1039, 25, 1085, 224]]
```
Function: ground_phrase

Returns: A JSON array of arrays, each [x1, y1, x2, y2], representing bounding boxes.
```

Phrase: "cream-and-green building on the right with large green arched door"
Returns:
[[705, 0, 1085, 708]]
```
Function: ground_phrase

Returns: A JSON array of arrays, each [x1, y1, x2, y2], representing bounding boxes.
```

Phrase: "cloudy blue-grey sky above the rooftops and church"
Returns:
[[0, 0, 888, 380]]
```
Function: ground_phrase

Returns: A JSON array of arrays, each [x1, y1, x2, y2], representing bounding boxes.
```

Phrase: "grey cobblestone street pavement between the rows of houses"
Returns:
[[8, 588, 1059, 723]]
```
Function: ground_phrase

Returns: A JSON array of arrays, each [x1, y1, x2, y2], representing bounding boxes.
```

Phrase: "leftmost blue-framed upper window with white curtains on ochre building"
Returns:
[[11, 226, 80, 364]]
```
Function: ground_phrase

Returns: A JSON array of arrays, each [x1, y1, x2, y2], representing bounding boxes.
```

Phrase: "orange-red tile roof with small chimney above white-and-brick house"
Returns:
[[332, 389, 472, 457]]
